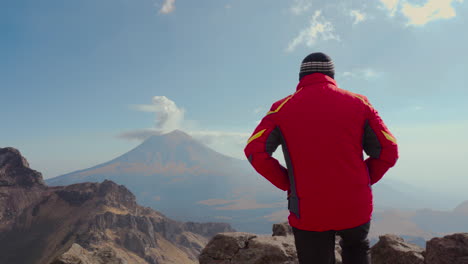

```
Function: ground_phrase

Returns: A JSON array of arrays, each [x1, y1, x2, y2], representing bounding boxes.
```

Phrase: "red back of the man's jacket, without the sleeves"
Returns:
[[272, 74, 372, 231]]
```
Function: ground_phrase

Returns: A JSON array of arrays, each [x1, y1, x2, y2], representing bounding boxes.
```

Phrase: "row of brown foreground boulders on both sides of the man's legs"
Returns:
[[199, 223, 468, 264]]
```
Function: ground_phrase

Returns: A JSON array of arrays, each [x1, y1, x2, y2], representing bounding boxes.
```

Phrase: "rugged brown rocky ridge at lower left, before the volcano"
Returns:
[[0, 148, 234, 264]]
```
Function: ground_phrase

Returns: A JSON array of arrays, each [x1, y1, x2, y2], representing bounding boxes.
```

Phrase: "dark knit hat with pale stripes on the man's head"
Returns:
[[299, 52, 335, 81]]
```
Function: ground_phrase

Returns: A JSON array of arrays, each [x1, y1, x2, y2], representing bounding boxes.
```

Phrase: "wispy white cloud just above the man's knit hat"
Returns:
[[286, 10, 340, 52]]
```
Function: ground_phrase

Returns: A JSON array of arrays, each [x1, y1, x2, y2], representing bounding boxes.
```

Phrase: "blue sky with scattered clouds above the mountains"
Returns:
[[0, 0, 468, 202]]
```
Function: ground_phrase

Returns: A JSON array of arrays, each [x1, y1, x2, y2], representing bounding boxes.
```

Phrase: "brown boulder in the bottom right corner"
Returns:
[[426, 233, 468, 264]]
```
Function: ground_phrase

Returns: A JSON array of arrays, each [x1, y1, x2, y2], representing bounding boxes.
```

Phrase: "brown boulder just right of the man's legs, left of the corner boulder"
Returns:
[[371, 235, 424, 264]]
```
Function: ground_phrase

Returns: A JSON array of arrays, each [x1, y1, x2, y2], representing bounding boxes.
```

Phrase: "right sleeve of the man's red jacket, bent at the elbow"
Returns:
[[363, 97, 398, 184]]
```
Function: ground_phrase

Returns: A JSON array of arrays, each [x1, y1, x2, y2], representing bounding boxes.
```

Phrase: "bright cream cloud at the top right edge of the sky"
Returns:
[[401, 0, 463, 26]]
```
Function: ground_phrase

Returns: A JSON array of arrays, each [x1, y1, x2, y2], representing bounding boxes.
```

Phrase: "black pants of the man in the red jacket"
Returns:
[[293, 222, 370, 264]]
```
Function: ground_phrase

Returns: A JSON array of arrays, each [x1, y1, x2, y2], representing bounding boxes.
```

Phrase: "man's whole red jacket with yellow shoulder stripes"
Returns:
[[246, 73, 396, 231]]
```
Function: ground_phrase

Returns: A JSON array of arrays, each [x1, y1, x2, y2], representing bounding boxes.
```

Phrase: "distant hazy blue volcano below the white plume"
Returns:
[[46, 130, 286, 232]]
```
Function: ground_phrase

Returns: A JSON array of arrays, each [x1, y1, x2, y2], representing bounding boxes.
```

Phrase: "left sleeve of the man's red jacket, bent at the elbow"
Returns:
[[244, 110, 289, 191]]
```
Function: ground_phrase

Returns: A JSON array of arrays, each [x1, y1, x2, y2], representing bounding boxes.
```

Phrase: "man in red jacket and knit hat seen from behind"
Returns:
[[245, 52, 398, 264]]
